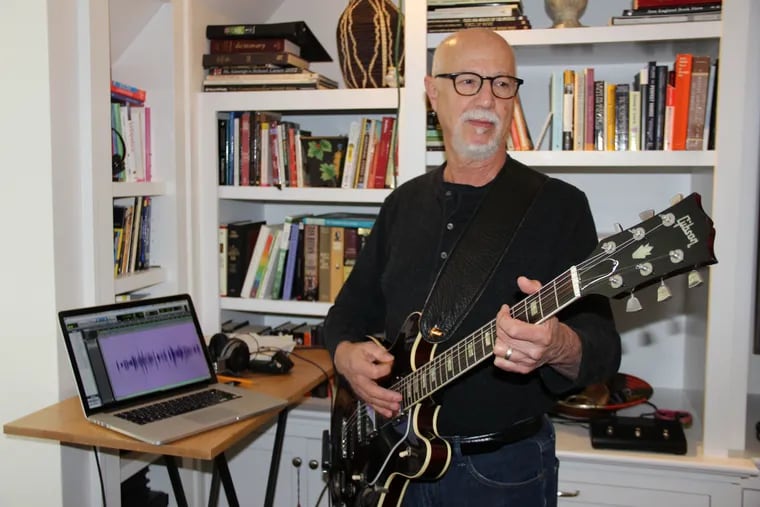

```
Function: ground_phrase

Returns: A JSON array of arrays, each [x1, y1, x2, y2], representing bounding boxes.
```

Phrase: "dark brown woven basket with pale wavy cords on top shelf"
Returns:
[[337, 0, 404, 88]]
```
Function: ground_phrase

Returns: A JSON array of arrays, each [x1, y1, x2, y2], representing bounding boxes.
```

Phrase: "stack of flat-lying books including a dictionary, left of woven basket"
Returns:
[[203, 21, 338, 92]]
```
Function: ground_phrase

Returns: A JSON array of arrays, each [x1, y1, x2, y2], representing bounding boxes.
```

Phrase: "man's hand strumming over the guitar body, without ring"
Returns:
[[334, 341, 401, 418]]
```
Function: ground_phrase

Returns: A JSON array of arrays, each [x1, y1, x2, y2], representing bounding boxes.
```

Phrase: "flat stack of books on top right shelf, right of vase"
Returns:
[[610, 0, 723, 25]]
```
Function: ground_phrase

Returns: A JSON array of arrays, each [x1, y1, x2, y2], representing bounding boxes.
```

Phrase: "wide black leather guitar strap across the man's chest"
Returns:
[[419, 158, 548, 343]]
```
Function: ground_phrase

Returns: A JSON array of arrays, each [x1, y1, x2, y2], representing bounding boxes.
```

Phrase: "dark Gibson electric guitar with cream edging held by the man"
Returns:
[[326, 193, 717, 507]]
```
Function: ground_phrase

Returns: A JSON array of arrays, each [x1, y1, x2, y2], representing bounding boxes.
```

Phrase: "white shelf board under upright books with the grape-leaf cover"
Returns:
[[219, 186, 390, 204]]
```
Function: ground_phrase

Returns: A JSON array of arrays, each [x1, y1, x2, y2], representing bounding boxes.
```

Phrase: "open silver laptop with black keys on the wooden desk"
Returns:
[[58, 294, 287, 445]]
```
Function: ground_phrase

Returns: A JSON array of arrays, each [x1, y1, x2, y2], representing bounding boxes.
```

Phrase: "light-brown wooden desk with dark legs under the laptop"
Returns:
[[3, 349, 333, 506]]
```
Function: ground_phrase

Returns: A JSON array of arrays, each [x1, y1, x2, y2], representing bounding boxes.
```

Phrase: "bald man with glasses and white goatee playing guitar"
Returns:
[[325, 29, 621, 507]]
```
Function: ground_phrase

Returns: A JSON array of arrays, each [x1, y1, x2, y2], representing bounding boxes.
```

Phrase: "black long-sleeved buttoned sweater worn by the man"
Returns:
[[324, 158, 621, 435]]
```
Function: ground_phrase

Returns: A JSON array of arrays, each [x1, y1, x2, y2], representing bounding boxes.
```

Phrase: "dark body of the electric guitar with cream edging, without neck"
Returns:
[[329, 313, 451, 507]]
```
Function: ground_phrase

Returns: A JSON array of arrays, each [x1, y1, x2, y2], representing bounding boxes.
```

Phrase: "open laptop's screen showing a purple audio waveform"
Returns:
[[62, 298, 213, 413]]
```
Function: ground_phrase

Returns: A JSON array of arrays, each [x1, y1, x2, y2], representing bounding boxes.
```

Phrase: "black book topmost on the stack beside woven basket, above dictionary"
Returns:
[[206, 21, 332, 62]]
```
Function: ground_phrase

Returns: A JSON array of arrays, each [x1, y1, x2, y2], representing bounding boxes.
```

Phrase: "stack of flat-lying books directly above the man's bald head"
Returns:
[[427, 0, 531, 33]]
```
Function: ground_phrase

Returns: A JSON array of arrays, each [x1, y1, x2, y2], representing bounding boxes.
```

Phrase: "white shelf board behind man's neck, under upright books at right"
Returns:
[[427, 150, 715, 172]]
